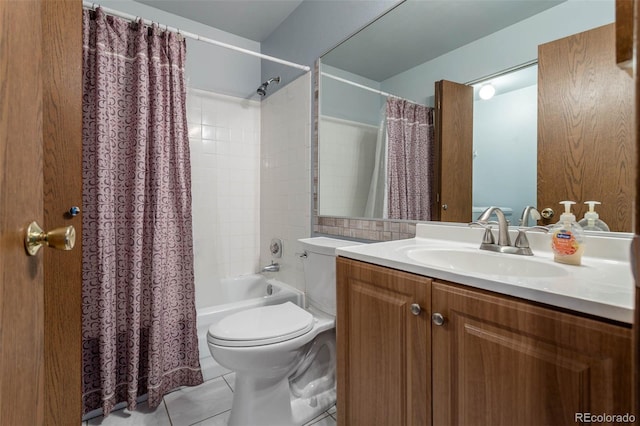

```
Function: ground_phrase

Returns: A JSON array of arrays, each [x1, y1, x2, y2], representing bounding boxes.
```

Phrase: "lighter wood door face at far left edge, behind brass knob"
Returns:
[[0, 0, 44, 425]]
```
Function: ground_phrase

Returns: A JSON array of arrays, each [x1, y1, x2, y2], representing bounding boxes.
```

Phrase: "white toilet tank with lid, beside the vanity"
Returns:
[[298, 237, 360, 315]]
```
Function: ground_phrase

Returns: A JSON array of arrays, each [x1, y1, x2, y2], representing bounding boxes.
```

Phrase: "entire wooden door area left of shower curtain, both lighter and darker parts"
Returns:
[[0, 0, 82, 425]]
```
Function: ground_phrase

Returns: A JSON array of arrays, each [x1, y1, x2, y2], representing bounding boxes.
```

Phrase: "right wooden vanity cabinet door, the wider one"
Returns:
[[432, 282, 631, 426]]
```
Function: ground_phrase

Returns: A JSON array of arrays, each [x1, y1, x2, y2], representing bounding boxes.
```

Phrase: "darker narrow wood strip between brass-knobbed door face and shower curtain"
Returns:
[[40, 0, 82, 426]]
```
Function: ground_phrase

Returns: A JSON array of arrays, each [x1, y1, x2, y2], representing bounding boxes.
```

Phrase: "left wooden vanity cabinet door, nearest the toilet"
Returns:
[[336, 258, 431, 426]]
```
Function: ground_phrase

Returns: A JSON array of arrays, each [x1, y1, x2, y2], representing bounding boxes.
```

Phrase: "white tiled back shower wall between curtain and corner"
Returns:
[[187, 89, 260, 308]]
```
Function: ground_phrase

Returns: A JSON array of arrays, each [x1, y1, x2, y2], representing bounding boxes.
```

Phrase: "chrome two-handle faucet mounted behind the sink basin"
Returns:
[[469, 207, 549, 256]]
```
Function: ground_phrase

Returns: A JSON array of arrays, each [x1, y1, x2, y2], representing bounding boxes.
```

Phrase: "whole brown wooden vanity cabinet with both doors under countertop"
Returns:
[[336, 258, 638, 426]]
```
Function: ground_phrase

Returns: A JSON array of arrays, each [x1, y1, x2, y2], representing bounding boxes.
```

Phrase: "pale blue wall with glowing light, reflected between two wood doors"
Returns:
[[473, 85, 538, 218]]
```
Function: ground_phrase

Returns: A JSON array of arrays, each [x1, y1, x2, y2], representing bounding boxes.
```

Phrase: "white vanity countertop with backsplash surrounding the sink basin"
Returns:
[[336, 224, 635, 324]]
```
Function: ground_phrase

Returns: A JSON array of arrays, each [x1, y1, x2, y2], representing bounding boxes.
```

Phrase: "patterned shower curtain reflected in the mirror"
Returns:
[[387, 97, 435, 220]]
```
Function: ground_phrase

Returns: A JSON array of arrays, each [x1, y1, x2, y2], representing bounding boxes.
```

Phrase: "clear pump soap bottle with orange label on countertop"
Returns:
[[550, 201, 584, 265]]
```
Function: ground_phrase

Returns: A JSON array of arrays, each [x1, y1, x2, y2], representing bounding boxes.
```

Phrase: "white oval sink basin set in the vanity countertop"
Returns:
[[407, 248, 568, 278]]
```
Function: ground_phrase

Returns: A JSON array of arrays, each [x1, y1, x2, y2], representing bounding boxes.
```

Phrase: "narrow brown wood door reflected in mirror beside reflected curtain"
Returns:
[[432, 80, 473, 222]]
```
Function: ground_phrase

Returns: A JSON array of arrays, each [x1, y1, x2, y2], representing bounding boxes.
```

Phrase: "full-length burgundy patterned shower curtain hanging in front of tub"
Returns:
[[82, 8, 202, 415]]
